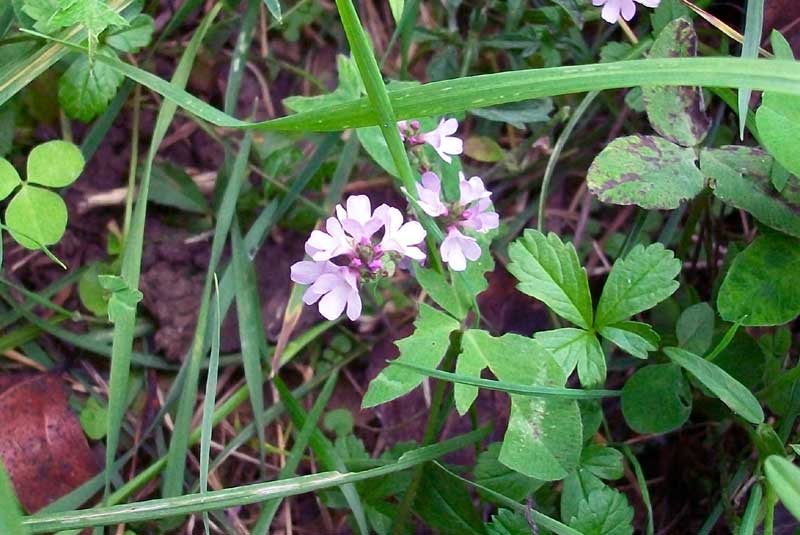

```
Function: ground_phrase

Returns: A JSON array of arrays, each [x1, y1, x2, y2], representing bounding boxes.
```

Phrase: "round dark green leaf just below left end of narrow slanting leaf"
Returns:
[[622, 363, 692, 434]]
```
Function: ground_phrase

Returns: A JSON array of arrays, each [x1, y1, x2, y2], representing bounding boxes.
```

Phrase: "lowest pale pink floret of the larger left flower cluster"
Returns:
[[291, 261, 361, 321]]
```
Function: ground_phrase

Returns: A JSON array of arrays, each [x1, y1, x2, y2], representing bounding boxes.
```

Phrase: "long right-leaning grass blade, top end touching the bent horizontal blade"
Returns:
[[163, 133, 252, 497]]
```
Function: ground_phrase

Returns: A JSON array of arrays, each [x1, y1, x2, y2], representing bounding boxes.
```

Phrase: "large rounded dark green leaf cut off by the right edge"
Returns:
[[717, 232, 800, 326]]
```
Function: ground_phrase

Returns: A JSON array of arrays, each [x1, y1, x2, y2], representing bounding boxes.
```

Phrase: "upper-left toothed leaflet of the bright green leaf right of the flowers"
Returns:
[[508, 229, 592, 329]]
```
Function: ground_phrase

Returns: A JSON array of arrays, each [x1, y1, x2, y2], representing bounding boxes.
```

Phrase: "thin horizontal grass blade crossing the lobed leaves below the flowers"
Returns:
[[387, 360, 622, 399]]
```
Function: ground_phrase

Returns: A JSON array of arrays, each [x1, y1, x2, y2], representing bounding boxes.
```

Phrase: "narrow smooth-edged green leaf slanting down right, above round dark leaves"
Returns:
[[664, 347, 764, 424]]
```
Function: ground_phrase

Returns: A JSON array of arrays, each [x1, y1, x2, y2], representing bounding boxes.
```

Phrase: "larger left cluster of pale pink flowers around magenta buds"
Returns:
[[291, 195, 425, 320]]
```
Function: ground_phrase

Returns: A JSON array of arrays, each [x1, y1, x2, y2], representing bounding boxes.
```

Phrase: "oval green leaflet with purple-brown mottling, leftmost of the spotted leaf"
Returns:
[[586, 134, 705, 210]]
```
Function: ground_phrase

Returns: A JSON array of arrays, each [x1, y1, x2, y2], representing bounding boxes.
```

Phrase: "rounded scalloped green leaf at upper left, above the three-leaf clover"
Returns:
[[58, 47, 124, 121]]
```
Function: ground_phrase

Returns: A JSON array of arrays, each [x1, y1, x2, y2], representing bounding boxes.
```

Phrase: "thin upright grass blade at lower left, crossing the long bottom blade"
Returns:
[[195, 277, 222, 535]]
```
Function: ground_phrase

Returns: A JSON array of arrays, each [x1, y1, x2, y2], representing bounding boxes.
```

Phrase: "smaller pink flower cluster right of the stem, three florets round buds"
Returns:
[[417, 172, 500, 271]]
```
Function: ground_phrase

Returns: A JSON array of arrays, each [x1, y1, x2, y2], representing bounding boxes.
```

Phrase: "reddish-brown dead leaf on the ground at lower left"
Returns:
[[0, 374, 99, 513]]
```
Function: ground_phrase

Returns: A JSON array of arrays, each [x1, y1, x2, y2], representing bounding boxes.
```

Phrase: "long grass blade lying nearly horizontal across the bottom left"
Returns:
[[23, 428, 488, 535]]
